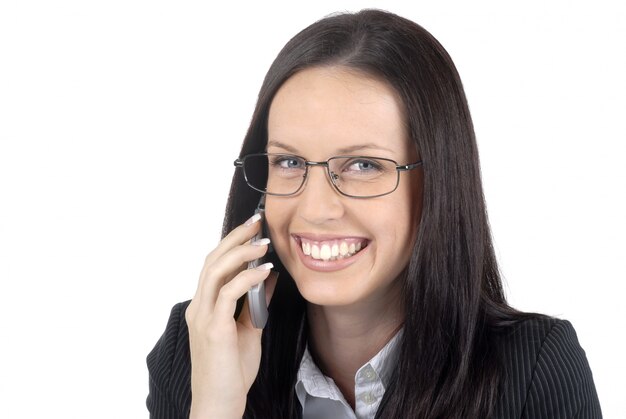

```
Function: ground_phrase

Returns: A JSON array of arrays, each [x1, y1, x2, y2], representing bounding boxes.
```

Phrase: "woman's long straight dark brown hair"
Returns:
[[223, 10, 526, 419]]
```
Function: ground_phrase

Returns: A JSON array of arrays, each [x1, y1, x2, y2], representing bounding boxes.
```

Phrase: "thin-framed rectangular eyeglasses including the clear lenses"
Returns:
[[234, 153, 422, 198]]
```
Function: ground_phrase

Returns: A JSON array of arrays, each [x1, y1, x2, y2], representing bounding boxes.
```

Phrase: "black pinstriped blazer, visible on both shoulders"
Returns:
[[146, 302, 602, 419]]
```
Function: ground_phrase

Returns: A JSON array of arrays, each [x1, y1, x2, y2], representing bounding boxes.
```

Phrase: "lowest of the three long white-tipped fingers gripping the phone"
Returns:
[[213, 263, 273, 323]]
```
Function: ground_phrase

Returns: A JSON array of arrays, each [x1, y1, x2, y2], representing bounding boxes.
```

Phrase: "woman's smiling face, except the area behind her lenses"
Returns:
[[266, 67, 422, 306]]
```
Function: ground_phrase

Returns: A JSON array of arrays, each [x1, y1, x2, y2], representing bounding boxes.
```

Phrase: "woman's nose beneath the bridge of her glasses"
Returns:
[[294, 166, 346, 225]]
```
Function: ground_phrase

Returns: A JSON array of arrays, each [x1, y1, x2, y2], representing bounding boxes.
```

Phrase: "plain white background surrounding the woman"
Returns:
[[0, 0, 626, 419]]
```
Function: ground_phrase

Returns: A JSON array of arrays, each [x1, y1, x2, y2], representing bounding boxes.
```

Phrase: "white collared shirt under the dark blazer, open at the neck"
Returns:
[[296, 330, 402, 419]]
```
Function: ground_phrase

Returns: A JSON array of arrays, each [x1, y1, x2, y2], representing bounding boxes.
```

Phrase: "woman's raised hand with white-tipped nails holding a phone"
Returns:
[[185, 215, 277, 418]]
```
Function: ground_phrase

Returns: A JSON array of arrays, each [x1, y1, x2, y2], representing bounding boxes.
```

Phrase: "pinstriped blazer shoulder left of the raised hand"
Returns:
[[146, 301, 191, 419]]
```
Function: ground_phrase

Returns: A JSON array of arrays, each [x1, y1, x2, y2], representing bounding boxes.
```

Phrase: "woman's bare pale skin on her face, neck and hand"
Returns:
[[186, 67, 422, 418]]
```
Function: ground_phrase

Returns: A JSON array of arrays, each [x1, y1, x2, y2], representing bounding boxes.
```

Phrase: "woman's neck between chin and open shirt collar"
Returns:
[[307, 287, 404, 408]]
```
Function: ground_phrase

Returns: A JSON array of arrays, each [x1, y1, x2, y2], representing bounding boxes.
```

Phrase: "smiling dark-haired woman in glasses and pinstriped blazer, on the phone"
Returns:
[[147, 10, 601, 419]]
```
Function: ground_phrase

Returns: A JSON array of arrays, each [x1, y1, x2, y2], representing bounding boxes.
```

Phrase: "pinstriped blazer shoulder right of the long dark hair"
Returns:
[[496, 315, 602, 418]]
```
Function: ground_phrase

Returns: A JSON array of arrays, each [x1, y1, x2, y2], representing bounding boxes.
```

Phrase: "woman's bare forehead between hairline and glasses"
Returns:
[[268, 67, 412, 158]]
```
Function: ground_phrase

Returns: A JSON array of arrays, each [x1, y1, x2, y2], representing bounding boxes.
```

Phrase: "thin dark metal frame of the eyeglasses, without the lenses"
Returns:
[[233, 153, 423, 199]]
